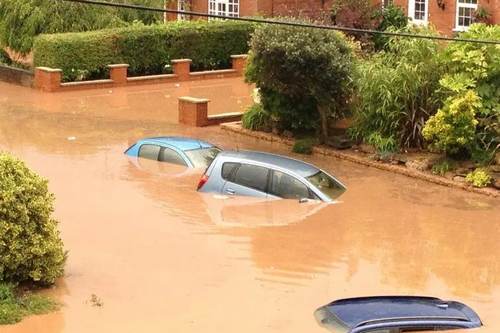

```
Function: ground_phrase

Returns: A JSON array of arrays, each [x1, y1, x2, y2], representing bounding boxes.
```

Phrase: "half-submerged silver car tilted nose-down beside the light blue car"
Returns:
[[198, 150, 346, 202]]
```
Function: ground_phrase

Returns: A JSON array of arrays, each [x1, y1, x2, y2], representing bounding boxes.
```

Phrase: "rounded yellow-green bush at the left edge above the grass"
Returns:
[[0, 153, 66, 284]]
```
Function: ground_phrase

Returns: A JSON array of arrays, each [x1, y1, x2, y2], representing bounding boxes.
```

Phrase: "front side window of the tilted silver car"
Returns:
[[269, 170, 314, 199]]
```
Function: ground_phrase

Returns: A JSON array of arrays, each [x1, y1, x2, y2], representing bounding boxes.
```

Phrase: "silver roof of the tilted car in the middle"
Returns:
[[219, 150, 320, 177]]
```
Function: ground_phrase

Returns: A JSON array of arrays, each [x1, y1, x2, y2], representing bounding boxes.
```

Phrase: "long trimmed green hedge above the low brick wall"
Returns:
[[33, 21, 255, 81]]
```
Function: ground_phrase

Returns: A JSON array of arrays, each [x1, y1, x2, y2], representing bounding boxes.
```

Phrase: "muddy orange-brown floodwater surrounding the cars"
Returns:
[[0, 79, 500, 333]]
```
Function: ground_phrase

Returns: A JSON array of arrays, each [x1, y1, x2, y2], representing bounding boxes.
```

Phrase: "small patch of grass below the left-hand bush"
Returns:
[[0, 282, 60, 325]]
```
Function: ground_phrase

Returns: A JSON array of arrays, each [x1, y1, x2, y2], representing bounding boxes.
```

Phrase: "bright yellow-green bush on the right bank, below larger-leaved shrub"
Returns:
[[423, 91, 481, 155]]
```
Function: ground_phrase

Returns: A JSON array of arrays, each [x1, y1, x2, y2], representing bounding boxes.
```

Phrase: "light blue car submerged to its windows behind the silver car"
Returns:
[[125, 136, 222, 168]]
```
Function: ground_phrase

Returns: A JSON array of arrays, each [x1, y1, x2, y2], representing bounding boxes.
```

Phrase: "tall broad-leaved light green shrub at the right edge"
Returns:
[[439, 24, 500, 156]]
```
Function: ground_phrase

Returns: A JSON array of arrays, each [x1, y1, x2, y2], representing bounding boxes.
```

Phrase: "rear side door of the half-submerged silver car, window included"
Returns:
[[221, 163, 270, 198]]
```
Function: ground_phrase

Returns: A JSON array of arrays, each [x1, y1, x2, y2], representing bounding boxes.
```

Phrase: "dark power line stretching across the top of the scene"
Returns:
[[54, 0, 500, 45]]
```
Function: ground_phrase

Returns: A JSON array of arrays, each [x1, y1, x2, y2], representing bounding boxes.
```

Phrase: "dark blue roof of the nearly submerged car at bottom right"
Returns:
[[326, 296, 480, 329]]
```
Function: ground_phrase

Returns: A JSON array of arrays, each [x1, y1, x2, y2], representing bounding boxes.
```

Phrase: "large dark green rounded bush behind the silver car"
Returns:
[[245, 19, 353, 135]]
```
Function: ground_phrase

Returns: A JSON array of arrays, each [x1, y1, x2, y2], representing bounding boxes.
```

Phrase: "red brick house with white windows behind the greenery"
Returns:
[[169, 0, 500, 35]]
